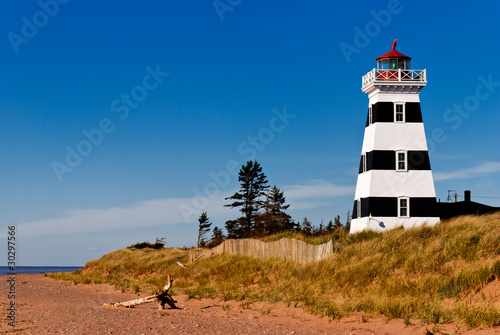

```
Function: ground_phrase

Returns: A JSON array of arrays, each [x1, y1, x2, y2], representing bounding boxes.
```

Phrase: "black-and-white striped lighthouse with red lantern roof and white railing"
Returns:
[[350, 40, 439, 233]]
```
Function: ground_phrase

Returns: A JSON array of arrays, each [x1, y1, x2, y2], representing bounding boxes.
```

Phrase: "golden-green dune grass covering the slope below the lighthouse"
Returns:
[[51, 213, 500, 327]]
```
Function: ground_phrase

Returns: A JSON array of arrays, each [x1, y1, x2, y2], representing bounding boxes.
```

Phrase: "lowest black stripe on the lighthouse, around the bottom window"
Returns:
[[352, 197, 437, 219]]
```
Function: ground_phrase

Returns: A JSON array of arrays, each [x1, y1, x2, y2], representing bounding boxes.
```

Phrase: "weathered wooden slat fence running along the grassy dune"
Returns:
[[188, 238, 333, 263]]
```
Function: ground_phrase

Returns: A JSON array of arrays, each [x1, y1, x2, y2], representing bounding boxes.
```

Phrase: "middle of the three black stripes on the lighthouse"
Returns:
[[358, 150, 431, 173]]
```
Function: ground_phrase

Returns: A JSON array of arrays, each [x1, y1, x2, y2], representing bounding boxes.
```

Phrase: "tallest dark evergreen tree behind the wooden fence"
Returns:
[[225, 161, 269, 237]]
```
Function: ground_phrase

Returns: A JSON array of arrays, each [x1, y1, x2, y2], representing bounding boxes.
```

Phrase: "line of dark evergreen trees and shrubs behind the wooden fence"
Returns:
[[197, 161, 350, 247]]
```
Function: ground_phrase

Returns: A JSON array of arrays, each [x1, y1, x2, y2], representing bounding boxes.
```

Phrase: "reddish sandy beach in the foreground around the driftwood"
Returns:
[[0, 274, 499, 334]]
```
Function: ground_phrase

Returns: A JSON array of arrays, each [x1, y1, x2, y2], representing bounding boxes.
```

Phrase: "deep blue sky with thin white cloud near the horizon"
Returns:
[[0, 0, 500, 265]]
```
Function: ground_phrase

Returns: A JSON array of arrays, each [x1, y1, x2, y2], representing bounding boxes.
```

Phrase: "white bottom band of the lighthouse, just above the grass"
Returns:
[[349, 217, 439, 234]]
